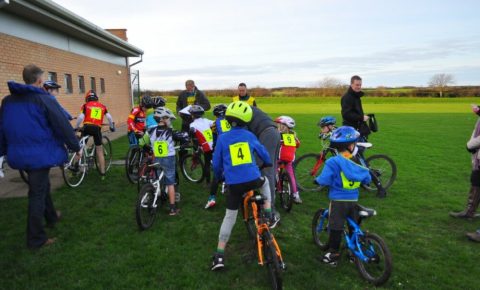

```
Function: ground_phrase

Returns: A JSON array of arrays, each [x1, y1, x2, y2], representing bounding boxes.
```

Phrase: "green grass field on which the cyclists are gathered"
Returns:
[[0, 98, 480, 289]]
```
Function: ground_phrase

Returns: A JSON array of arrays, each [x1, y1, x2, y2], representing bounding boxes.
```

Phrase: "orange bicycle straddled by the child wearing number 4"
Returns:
[[243, 190, 286, 289]]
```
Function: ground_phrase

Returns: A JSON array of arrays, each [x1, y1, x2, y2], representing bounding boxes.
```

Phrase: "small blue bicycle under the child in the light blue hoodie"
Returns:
[[312, 205, 393, 286]]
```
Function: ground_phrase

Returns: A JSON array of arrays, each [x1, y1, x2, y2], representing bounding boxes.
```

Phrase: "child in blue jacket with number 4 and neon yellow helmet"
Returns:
[[211, 101, 277, 270]]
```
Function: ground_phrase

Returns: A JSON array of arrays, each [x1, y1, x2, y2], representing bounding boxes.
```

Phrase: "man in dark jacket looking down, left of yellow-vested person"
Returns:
[[177, 80, 210, 132]]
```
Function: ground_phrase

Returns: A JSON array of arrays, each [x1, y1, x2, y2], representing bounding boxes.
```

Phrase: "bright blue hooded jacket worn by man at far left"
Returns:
[[0, 81, 80, 170]]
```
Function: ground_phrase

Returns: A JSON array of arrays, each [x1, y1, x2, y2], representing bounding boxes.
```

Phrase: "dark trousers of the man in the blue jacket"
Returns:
[[27, 168, 58, 248]]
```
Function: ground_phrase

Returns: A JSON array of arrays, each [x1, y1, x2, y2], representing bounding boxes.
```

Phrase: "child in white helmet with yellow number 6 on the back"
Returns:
[[148, 107, 186, 216]]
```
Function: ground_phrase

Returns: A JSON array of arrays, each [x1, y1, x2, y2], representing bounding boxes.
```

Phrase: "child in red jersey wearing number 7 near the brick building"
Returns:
[[75, 90, 115, 180]]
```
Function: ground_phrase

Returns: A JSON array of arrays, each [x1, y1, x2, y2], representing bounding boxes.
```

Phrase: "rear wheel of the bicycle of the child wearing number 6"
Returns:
[[135, 183, 161, 230]]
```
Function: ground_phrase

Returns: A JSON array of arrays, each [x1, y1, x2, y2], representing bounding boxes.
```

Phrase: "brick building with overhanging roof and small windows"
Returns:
[[0, 0, 143, 127]]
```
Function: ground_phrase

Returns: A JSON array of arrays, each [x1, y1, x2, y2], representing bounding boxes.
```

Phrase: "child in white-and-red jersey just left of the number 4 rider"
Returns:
[[188, 105, 213, 184]]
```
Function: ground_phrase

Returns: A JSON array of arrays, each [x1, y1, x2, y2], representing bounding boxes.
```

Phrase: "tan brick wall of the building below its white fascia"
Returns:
[[0, 33, 131, 127]]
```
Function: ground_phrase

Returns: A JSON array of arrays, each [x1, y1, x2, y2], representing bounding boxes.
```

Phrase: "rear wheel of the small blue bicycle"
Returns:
[[355, 233, 393, 286]]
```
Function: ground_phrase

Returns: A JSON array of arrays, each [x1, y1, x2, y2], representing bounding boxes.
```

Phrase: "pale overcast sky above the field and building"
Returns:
[[55, 0, 480, 90]]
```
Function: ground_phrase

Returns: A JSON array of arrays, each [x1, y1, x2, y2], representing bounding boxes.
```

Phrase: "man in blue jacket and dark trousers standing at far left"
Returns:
[[0, 65, 81, 249]]
